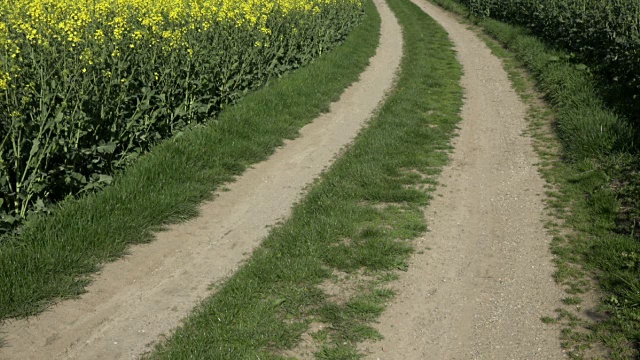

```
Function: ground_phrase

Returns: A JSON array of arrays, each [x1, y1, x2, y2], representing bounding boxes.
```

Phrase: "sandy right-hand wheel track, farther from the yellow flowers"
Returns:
[[361, 0, 565, 360]]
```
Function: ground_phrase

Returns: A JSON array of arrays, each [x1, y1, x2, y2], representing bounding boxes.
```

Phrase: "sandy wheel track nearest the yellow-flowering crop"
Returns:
[[0, 0, 402, 360]]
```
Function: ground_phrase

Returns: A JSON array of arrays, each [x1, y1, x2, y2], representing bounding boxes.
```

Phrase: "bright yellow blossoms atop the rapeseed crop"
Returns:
[[0, 0, 360, 90]]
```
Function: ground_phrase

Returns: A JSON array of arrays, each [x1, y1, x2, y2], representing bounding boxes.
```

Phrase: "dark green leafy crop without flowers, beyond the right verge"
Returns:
[[457, 0, 640, 123]]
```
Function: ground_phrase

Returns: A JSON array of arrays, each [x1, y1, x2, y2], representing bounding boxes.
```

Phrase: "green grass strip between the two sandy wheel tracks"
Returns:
[[149, 0, 462, 360]]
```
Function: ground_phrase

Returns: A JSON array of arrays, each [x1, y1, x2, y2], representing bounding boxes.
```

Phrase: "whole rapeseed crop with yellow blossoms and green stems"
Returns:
[[0, 0, 363, 234]]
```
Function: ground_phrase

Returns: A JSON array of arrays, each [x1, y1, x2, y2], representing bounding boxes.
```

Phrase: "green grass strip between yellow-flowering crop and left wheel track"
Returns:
[[0, 2, 380, 319]]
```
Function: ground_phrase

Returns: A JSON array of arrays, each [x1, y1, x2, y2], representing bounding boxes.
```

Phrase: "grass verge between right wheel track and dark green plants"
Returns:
[[424, 0, 640, 359]]
